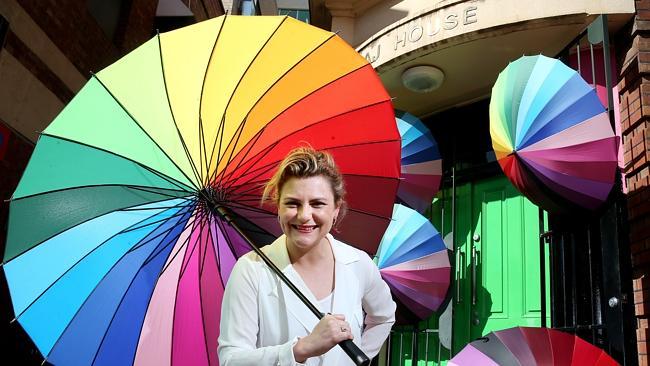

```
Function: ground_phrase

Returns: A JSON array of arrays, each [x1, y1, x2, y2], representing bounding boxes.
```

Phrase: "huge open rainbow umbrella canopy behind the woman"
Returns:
[[3, 16, 400, 365]]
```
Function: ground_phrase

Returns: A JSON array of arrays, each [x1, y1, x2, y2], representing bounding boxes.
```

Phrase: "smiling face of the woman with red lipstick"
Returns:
[[278, 175, 340, 251]]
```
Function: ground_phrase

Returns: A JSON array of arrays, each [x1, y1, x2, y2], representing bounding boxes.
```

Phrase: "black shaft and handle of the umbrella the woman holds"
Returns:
[[215, 206, 370, 366]]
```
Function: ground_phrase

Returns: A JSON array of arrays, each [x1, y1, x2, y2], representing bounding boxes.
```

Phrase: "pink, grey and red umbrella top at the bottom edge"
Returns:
[[449, 327, 618, 366]]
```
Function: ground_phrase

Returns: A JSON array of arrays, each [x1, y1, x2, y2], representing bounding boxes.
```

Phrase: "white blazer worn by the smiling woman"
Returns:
[[218, 234, 396, 366]]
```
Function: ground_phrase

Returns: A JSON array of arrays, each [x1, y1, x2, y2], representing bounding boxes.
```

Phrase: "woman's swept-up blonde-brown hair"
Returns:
[[262, 146, 345, 219]]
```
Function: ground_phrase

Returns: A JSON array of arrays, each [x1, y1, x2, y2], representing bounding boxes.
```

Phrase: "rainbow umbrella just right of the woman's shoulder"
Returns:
[[375, 204, 451, 319]]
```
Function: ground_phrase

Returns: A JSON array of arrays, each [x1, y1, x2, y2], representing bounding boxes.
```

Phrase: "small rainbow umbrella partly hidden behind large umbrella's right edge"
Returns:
[[395, 111, 442, 213]]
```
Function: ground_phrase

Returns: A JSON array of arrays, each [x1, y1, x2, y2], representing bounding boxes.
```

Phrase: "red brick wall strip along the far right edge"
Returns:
[[618, 0, 650, 365]]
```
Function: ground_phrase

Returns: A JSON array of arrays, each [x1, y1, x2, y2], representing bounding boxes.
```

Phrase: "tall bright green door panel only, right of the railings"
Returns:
[[446, 176, 548, 354]]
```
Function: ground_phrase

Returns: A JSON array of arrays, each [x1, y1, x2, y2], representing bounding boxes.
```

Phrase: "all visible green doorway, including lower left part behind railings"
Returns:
[[386, 175, 549, 366]]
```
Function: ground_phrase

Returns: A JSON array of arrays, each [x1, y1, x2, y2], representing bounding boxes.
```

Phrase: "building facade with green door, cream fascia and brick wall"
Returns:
[[310, 0, 650, 365]]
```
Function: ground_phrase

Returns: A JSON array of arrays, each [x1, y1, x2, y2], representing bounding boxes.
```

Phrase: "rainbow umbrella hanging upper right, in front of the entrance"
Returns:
[[490, 56, 618, 211]]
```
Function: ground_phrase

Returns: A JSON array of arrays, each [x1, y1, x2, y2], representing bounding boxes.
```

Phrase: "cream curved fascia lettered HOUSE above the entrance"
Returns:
[[354, 0, 634, 67]]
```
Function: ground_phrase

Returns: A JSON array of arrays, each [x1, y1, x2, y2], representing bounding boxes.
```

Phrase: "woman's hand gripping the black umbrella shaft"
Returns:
[[293, 314, 354, 363]]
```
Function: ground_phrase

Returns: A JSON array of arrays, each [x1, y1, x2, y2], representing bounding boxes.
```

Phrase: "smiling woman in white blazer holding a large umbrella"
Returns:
[[218, 147, 395, 366]]
